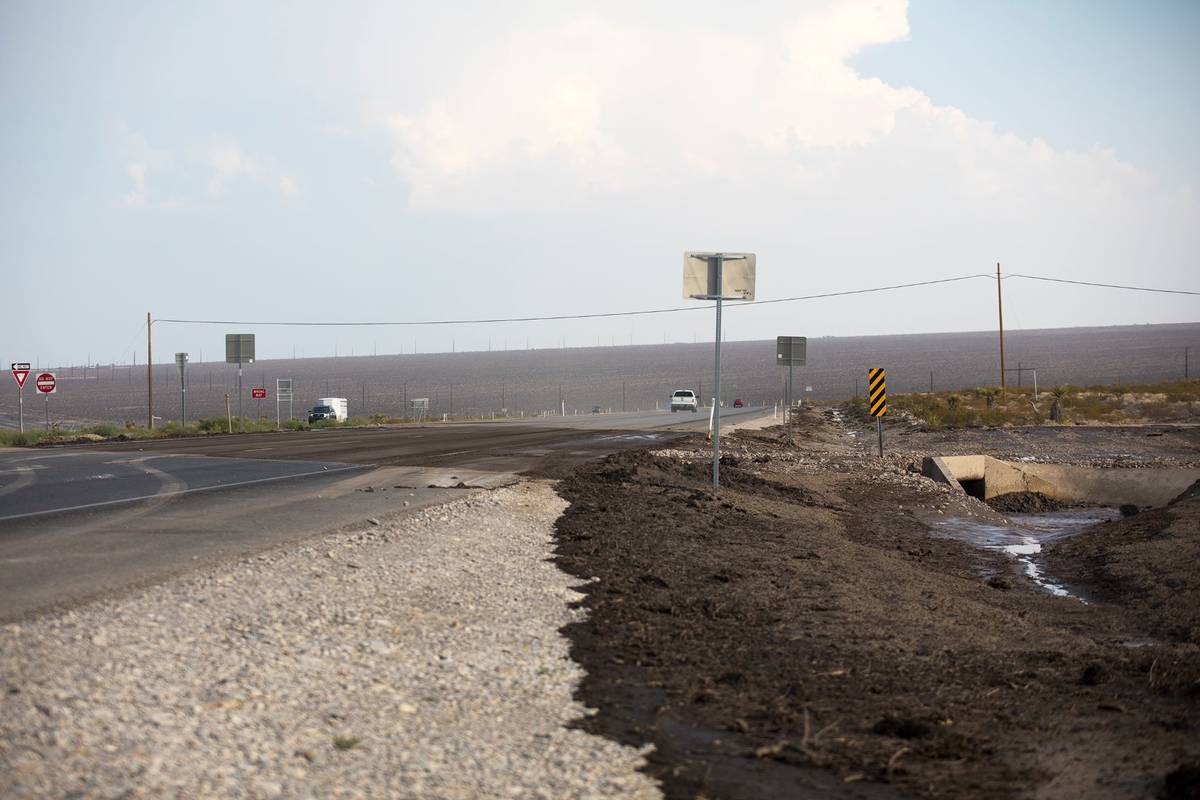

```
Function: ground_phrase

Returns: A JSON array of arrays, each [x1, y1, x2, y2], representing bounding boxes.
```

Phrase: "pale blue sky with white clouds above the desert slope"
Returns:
[[0, 0, 1200, 365]]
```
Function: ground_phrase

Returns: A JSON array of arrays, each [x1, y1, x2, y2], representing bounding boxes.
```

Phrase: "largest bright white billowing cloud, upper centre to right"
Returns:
[[373, 0, 1194, 242]]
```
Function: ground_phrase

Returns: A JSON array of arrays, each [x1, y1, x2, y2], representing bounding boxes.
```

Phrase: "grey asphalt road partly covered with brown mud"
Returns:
[[0, 409, 762, 621]]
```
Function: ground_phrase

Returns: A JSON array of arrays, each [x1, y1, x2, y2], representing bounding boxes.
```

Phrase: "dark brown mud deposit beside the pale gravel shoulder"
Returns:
[[558, 411, 1200, 798]]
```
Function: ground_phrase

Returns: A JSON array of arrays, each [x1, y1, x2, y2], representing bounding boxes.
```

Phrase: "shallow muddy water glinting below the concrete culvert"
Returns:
[[932, 507, 1121, 602]]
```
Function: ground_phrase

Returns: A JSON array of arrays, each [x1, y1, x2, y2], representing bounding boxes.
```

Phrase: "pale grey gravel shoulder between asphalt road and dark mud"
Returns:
[[0, 482, 661, 798]]
